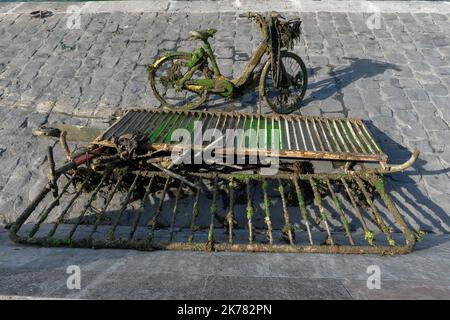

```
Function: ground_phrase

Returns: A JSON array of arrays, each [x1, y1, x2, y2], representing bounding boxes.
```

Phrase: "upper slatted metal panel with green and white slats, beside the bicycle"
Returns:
[[95, 110, 387, 162]]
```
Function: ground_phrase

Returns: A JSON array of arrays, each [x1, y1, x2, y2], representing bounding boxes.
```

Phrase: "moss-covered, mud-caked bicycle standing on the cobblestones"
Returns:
[[148, 11, 308, 114]]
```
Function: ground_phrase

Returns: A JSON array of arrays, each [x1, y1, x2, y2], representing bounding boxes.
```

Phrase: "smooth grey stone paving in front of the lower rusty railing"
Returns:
[[0, 225, 450, 300]]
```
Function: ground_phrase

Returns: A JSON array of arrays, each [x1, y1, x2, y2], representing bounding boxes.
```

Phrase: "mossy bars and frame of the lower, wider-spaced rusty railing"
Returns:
[[10, 169, 416, 255]]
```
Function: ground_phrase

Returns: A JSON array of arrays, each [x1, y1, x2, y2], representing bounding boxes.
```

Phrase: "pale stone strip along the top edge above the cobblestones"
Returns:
[[0, 0, 450, 14]]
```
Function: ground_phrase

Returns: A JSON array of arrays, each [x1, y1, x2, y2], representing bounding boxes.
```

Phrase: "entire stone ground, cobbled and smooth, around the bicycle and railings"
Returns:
[[0, 0, 450, 299]]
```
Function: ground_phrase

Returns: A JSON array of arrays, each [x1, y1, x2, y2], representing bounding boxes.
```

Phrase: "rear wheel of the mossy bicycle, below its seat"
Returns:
[[148, 53, 209, 110]]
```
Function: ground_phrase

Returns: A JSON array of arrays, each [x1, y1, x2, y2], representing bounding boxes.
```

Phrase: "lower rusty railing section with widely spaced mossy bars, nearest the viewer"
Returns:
[[10, 168, 415, 254]]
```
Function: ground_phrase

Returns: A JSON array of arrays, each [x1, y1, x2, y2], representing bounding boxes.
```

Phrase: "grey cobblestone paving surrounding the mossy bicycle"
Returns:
[[0, 1, 450, 238]]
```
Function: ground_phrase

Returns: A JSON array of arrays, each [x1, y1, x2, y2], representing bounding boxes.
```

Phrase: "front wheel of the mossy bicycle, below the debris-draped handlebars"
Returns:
[[259, 51, 308, 114]]
